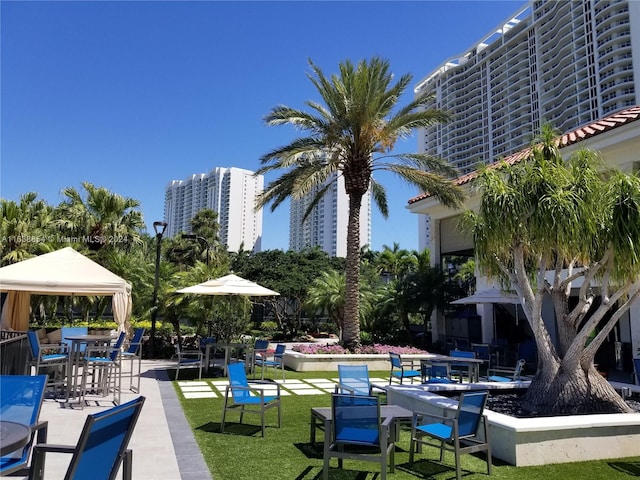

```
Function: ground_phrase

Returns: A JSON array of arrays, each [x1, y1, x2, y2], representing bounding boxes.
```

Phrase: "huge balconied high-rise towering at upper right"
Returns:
[[414, 0, 640, 249]]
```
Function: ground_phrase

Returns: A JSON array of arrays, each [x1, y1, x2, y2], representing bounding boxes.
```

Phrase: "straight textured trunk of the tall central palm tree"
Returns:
[[342, 193, 362, 348]]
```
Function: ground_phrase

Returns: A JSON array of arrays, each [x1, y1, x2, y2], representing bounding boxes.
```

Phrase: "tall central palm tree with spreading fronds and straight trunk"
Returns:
[[256, 57, 463, 348]]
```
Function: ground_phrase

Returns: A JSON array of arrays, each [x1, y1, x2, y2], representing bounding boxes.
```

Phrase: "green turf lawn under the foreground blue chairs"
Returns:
[[174, 371, 640, 480]]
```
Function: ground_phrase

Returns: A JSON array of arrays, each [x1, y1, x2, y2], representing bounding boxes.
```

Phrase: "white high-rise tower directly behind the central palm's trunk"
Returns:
[[289, 174, 371, 257]]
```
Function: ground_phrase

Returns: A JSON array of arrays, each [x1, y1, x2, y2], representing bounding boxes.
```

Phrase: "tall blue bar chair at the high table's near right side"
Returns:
[[80, 332, 127, 408]]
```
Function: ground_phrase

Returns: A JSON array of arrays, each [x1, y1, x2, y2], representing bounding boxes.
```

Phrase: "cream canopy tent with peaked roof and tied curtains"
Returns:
[[0, 247, 131, 331]]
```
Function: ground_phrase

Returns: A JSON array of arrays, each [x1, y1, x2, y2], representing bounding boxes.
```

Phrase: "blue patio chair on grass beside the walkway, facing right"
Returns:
[[220, 362, 282, 437]]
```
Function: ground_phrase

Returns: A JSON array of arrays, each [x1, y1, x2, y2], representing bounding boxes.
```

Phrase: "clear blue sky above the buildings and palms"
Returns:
[[0, 0, 525, 250]]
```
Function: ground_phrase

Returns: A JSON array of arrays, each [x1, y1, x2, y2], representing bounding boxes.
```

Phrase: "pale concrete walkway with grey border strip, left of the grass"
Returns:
[[33, 360, 211, 480]]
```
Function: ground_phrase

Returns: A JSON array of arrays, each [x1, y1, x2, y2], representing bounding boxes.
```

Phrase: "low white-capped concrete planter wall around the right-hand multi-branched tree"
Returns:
[[387, 382, 640, 466]]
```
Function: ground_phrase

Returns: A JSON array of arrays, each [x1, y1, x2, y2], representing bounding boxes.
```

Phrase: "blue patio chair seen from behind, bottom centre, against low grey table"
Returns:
[[322, 394, 395, 480]]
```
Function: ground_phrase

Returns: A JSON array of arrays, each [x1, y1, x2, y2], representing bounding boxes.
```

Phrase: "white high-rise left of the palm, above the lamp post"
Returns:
[[164, 167, 264, 252]]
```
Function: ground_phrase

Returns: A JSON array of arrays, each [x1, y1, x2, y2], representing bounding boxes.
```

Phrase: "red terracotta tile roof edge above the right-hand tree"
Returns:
[[408, 105, 640, 204]]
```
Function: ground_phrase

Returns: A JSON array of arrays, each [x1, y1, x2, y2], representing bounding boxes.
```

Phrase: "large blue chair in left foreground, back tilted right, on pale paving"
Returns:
[[29, 397, 145, 480]]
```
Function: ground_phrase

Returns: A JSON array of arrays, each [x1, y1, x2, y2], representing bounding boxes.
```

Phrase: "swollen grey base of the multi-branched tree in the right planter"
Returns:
[[522, 362, 631, 416]]
